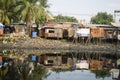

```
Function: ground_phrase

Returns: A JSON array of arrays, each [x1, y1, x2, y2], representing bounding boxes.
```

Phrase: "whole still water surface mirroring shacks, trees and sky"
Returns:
[[0, 50, 120, 80]]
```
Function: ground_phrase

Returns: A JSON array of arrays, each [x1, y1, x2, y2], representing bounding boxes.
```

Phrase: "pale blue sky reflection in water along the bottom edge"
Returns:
[[44, 70, 112, 80]]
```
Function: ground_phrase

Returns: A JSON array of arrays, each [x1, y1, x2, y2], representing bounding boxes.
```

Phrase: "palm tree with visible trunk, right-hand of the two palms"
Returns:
[[19, 0, 47, 34]]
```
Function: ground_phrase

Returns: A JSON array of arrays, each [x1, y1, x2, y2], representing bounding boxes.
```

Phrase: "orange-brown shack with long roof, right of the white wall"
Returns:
[[86, 24, 117, 39]]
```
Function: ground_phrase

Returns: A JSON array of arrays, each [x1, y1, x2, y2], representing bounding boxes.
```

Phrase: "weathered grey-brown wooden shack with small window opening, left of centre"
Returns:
[[39, 24, 63, 38]]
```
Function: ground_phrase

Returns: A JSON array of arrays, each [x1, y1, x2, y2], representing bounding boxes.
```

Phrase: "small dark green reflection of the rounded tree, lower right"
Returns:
[[91, 69, 110, 79]]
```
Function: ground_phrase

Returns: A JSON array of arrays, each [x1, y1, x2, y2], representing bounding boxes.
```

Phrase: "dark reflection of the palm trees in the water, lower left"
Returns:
[[0, 63, 49, 80]]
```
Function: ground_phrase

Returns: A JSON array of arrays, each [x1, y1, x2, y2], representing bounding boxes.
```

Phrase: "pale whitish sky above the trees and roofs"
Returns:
[[48, 0, 120, 22]]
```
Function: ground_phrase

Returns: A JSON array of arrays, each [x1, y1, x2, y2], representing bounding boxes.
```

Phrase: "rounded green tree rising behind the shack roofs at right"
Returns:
[[90, 12, 113, 24]]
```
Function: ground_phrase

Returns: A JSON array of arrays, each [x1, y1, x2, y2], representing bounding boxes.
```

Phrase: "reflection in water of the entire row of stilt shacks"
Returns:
[[31, 52, 117, 70]]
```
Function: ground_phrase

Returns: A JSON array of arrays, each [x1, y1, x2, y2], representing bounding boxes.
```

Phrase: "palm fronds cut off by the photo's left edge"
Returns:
[[0, 0, 18, 24]]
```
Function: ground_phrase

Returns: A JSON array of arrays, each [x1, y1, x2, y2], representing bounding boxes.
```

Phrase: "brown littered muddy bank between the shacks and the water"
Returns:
[[0, 37, 120, 53]]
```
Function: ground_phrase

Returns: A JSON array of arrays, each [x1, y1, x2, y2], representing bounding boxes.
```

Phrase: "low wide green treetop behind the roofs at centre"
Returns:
[[54, 15, 78, 22]]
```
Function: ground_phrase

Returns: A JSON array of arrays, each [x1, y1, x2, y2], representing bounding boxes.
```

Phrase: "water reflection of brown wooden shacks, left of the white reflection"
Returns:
[[37, 53, 73, 67]]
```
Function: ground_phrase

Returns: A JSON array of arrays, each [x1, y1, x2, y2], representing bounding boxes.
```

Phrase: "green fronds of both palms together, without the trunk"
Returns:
[[0, 0, 48, 24]]
